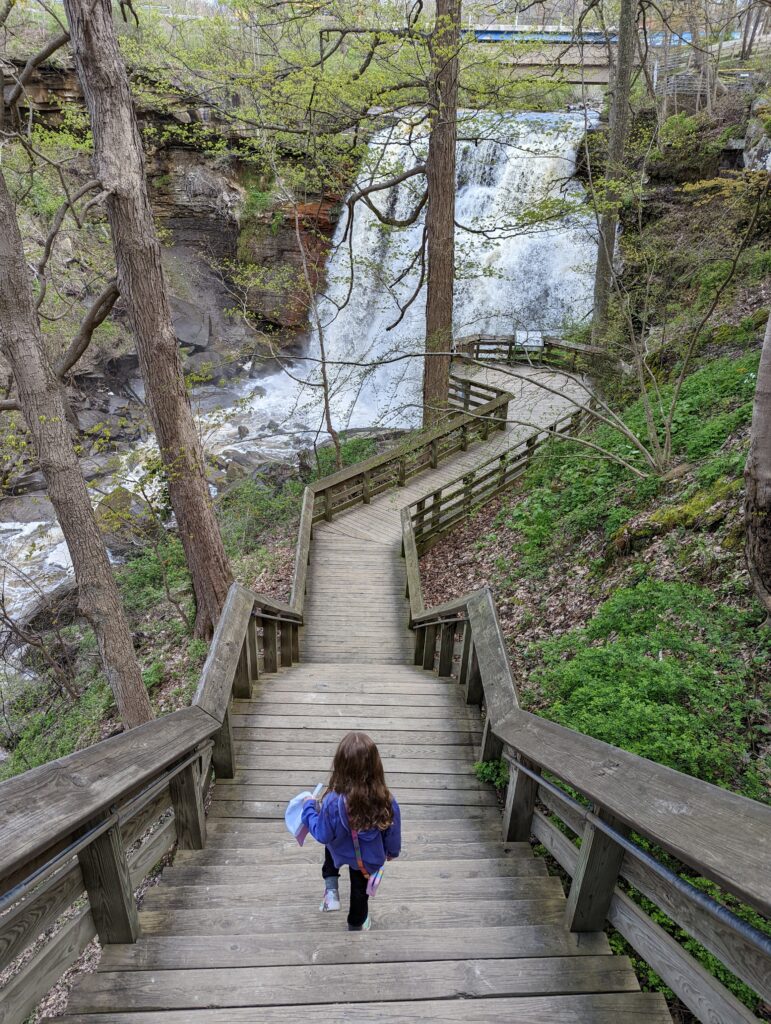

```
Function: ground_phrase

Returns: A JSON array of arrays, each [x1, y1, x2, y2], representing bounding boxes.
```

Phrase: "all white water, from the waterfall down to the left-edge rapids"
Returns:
[[0, 113, 596, 611]]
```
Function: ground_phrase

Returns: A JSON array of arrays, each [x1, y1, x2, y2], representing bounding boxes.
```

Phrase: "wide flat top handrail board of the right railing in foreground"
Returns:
[[497, 710, 771, 913]]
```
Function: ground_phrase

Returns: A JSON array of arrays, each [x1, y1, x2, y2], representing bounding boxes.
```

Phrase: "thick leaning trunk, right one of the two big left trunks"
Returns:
[[65, 0, 231, 635]]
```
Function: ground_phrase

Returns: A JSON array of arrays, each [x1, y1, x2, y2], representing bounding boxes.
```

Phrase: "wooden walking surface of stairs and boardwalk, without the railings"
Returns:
[[56, 371, 670, 1024]]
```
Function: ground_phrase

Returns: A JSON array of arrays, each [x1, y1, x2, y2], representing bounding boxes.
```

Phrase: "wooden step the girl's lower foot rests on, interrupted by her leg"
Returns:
[[139, 895, 566, 937]]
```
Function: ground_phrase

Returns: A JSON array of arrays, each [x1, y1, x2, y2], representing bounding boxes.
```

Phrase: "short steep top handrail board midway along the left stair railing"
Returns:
[[192, 583, 254, 722]]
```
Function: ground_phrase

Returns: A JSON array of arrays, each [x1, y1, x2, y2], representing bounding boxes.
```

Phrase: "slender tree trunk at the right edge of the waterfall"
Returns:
[[592, 0, 637, 344]]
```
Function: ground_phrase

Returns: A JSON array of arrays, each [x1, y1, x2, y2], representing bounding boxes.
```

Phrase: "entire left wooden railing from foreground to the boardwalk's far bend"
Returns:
[[0, 364, 518, 1024]]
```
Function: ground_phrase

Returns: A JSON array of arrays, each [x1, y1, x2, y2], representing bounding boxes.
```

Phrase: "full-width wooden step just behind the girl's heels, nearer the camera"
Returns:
[[99, 925, 610, 973]]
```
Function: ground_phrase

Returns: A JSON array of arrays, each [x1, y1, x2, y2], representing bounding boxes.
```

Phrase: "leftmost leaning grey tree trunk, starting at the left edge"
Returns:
[[0, 174, 153, 729]]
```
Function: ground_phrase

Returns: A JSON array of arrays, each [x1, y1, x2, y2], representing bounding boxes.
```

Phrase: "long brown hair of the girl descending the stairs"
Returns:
[[329, 732, 393, 831]]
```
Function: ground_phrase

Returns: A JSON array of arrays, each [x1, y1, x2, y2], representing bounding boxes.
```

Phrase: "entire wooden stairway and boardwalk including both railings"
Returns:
[[0, 342, 771, 1024]]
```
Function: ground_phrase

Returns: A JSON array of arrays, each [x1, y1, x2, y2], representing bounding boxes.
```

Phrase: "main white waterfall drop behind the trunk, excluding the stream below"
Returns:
[[309, 113, 596, 426]]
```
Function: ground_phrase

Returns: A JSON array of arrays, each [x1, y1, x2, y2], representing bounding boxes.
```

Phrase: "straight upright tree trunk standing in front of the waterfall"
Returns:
[[423, 0, 461, 426]]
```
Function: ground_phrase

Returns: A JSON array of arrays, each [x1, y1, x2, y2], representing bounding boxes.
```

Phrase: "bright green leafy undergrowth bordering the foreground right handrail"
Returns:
[[529, 580, 771, 797]]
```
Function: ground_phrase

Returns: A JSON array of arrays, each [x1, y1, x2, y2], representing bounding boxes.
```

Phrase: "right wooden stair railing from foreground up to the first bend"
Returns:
[[401, 499, 771, 1024]]
